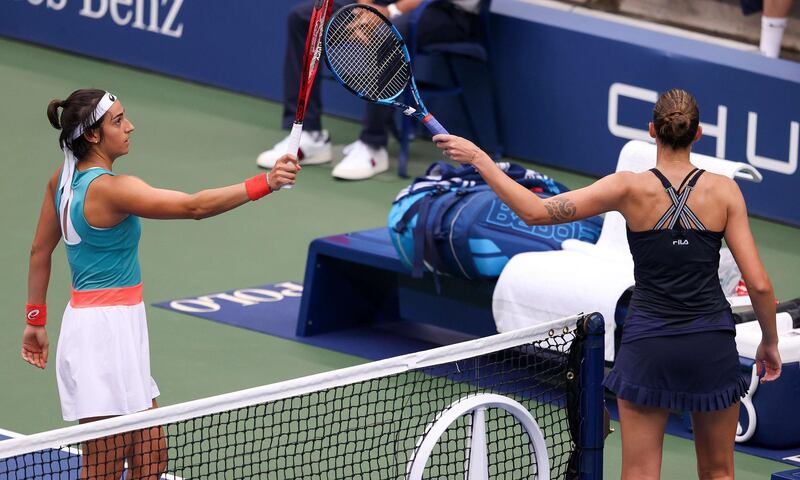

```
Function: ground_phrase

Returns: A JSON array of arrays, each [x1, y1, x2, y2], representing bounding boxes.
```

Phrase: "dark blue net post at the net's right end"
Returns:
[[580, 313, 605, 480]]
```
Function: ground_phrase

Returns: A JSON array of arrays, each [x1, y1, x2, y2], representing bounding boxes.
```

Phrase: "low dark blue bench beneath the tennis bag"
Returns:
[[297, 227, 497, 337]]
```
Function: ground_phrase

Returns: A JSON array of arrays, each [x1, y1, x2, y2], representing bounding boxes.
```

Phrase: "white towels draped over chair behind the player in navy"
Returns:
[[492, 140, 762, 361]]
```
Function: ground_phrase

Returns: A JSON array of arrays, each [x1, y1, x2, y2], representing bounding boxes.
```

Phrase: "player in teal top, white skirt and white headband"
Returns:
[[22, 90, 300, 478]]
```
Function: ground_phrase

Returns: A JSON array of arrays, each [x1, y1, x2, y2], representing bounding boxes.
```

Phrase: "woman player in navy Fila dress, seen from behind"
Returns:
[[434, 89, 781, 480]]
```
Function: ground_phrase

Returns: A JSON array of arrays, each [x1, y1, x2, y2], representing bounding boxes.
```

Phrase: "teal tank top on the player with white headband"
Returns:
[[56, 168, 142, 290]]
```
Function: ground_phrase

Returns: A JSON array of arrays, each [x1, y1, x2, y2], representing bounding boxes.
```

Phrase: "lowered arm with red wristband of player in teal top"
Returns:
[[21, 172, 61, 368]]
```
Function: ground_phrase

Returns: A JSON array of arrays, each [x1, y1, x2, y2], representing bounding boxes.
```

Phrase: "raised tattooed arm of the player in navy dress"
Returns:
[[433, 135, 631, 225]]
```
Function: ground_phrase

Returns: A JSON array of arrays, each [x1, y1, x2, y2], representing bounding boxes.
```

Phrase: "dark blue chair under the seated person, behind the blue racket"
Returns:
[[398, 0, 502, 178]]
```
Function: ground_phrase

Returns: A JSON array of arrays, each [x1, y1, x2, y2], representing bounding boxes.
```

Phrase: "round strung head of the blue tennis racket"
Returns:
[[323, 4, 413, 104]]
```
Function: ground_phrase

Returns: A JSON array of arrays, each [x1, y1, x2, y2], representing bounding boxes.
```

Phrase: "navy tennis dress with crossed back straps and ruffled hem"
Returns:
[[603, 168, 748, 411]]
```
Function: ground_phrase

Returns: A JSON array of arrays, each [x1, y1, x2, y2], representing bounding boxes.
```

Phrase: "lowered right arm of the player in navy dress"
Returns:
[[725, 181, 781, 382]]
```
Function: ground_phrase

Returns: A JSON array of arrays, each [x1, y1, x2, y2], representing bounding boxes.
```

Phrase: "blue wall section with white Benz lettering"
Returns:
[[0, 0, 310, 99]]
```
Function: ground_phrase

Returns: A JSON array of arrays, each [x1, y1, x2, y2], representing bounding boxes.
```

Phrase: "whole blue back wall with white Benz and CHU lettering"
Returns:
[[0, 0, 800, 225]]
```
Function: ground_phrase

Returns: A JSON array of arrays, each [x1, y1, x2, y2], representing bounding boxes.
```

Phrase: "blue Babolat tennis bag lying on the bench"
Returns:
[[388, 162, 602, 279]]
